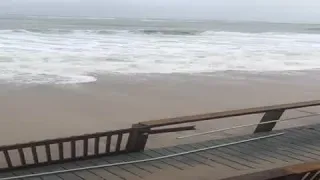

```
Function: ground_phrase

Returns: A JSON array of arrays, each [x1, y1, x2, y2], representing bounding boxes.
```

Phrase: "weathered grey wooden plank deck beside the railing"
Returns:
[[0, 124, 320, 180]]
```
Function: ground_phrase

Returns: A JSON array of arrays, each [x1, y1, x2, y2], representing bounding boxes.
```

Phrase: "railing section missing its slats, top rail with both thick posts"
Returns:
[[129, 100, 320, 151]]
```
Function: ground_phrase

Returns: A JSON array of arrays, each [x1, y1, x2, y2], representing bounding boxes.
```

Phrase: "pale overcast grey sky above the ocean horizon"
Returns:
[[0, 0, 320, 23]]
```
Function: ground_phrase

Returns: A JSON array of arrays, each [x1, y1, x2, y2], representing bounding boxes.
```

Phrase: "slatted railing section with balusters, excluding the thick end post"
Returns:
[[0, 129, 131, 170]]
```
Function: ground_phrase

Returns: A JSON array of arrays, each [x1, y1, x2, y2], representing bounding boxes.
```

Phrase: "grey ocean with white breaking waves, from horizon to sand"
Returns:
[[0, 17, 320, 84]]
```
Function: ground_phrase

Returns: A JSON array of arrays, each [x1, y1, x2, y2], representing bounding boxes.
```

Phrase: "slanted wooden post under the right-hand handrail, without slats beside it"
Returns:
[[254, 109, 285, 133]]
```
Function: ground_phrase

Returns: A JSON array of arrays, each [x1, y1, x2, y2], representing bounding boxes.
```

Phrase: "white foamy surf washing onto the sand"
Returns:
[[0, 30, 320, 83]]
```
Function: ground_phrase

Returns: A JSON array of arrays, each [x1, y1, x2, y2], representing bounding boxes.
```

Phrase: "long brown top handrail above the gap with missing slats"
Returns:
[[139, 100, 320, 128]]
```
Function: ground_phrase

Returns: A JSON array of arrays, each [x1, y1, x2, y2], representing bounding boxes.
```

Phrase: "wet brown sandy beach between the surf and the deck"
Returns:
[[0, 71, 320, 147]]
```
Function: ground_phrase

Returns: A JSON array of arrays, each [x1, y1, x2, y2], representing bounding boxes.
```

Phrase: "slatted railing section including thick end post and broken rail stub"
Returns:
[[0, 126, 195, 172]]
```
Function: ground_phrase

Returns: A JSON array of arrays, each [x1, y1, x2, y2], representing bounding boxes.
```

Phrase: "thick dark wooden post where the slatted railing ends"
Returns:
[[126, 124, 150, 152]]
